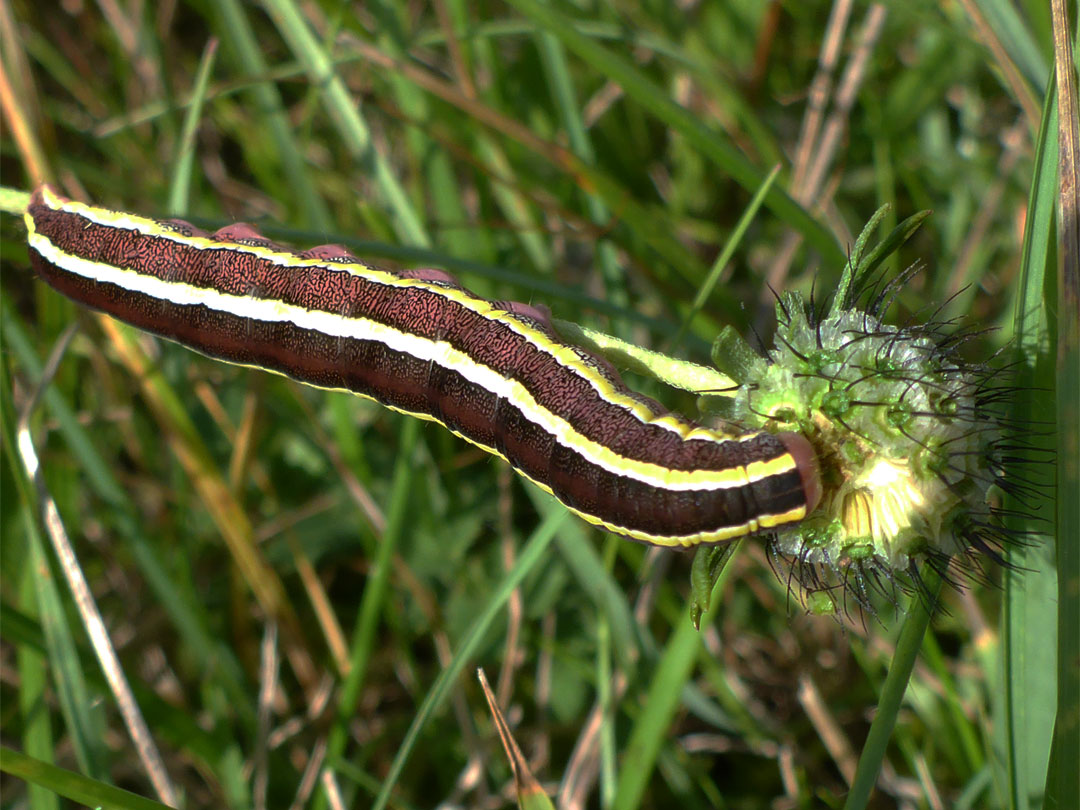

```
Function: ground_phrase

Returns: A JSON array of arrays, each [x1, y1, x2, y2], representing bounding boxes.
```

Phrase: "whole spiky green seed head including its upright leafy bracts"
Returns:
[[691, 212, 1038, 612]]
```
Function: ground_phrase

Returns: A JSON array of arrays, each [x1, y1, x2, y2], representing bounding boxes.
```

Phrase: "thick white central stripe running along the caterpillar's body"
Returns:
[[29, 226, 786, 491]]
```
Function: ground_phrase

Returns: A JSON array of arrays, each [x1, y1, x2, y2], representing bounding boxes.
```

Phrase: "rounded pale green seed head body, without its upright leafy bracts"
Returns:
[[734, 294, 997, 570]]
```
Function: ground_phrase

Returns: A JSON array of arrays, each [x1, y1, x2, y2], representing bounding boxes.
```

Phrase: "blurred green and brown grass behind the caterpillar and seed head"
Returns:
[[0, 0, 1067, 810]]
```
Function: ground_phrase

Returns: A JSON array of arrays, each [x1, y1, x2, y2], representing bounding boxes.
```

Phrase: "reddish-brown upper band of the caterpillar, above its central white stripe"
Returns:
[[31, 203, 786, 479]]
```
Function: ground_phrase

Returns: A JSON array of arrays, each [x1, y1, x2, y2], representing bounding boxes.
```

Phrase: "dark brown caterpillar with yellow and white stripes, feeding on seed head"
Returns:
[[25, 185, 821, 546]]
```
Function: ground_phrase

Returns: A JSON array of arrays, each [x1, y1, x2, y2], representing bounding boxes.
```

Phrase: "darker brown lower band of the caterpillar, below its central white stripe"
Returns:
[[30, 249, 804, 536]]
